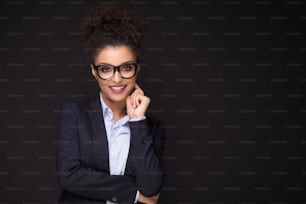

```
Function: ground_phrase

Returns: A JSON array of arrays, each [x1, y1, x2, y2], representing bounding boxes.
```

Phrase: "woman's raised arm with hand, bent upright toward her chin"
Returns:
[[126, 84, 165, 197]]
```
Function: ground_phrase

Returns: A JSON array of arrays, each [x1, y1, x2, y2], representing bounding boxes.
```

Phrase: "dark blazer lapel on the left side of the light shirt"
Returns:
[[88, 94, 109, 173]]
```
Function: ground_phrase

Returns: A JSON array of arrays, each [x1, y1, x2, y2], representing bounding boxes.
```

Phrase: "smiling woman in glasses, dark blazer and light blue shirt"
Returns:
[[57, 2, 164, 203]]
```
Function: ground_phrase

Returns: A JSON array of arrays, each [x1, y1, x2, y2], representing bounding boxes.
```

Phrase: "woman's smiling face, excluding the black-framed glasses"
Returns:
[[91, 45, 139, 105]]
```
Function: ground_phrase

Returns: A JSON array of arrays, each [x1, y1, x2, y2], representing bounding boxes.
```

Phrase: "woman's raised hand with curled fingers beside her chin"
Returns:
[[126, 84, 151, 119]]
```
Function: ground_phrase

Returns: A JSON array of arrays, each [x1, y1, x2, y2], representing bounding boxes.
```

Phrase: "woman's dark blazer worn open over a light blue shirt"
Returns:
[[57, 94, 164, 203]]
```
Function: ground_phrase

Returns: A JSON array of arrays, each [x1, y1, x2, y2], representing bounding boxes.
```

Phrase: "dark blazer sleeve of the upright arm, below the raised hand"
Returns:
[[130, 119, 165, 197]]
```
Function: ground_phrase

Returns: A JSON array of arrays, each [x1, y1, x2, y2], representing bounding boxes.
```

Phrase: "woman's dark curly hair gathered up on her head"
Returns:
[[81, 3, 149, 63]]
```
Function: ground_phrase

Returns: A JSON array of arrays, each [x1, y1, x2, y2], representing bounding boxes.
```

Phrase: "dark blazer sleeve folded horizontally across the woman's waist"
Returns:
[[57, 104, 137, 203]]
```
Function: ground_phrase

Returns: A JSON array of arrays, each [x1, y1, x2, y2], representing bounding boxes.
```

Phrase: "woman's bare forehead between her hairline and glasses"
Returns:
[[95, 45, 136, 66]]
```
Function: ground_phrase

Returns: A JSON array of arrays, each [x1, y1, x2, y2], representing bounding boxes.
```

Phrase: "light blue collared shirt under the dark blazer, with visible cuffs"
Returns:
[[100, 92, 145, 204]]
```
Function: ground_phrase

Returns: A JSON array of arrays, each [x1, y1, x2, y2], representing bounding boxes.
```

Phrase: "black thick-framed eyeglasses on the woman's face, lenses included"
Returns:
[[92, 63, 138, 80]]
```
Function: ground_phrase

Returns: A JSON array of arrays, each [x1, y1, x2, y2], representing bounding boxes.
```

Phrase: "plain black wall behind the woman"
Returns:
[[0, 0, 306, 204]]
